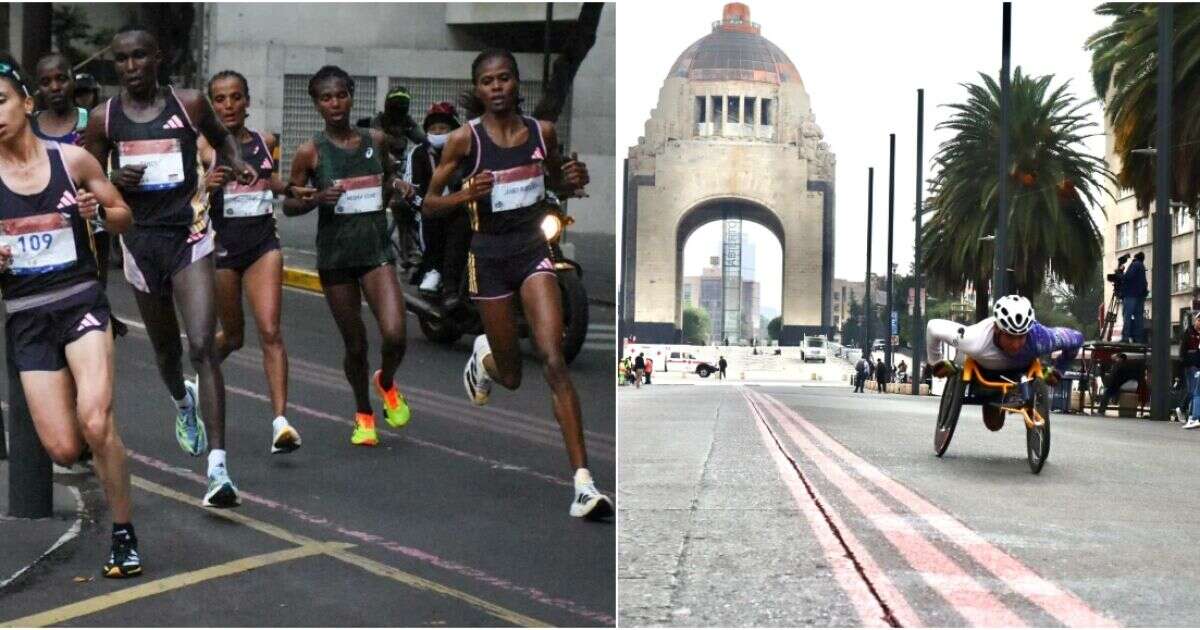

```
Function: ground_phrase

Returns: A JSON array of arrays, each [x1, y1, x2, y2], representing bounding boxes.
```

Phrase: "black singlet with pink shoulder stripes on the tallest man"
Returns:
[[104, 88, 203, 226]]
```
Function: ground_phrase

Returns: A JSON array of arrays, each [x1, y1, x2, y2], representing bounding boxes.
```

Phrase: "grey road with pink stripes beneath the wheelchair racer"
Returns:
[[618, 385, 1200, 626]]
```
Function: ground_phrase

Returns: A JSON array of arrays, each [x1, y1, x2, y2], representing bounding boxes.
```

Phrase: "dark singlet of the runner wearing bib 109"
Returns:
[[0, 140, 97, 300]]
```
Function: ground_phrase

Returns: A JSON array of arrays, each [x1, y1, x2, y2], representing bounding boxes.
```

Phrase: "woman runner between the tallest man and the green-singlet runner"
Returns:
[[198, 70, 314, 454]]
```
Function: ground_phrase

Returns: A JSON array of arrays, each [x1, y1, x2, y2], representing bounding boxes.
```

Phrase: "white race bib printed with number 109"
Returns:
[[0, 212, 76, 276]]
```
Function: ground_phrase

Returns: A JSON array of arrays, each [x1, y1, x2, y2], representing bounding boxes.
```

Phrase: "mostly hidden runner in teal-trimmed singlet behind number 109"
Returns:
[[34, 53, 128, 337]]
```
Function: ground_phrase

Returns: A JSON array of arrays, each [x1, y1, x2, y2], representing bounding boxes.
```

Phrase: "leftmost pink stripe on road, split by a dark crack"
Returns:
[[742, 390, 920, 628]]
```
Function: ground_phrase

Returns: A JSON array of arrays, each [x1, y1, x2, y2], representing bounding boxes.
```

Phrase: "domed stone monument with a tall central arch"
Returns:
[[620, 2, 834, 344]]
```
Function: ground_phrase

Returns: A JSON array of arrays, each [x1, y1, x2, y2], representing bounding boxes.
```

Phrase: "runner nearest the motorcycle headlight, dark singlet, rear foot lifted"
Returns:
[[422, 49, 613, 518]]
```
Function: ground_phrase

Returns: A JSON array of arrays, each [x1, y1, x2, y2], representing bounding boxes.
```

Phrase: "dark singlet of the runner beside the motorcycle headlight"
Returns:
[[464, 116, 547, 257]]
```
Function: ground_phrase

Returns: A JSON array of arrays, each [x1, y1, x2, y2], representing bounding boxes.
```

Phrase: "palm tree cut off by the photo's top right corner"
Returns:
[[1087, 2, 1200, 208]]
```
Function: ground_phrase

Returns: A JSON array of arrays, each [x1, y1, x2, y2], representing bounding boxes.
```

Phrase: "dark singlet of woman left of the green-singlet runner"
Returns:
[[209, 130, 275, 251]]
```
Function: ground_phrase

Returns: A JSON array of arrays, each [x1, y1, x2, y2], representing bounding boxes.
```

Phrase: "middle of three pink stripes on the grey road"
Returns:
[[750, 392, 1027, 628]]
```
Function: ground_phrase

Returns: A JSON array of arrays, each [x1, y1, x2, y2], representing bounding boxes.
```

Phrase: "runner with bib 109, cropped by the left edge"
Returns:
[[0, 59, 142, 577]]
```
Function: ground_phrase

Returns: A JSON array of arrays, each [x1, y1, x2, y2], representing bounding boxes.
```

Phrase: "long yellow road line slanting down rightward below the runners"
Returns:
[[129, 475, 550, 628]]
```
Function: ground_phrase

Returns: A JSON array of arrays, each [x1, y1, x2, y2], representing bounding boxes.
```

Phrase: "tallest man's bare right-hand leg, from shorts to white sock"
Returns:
[[172, 256, 226, 450]]
